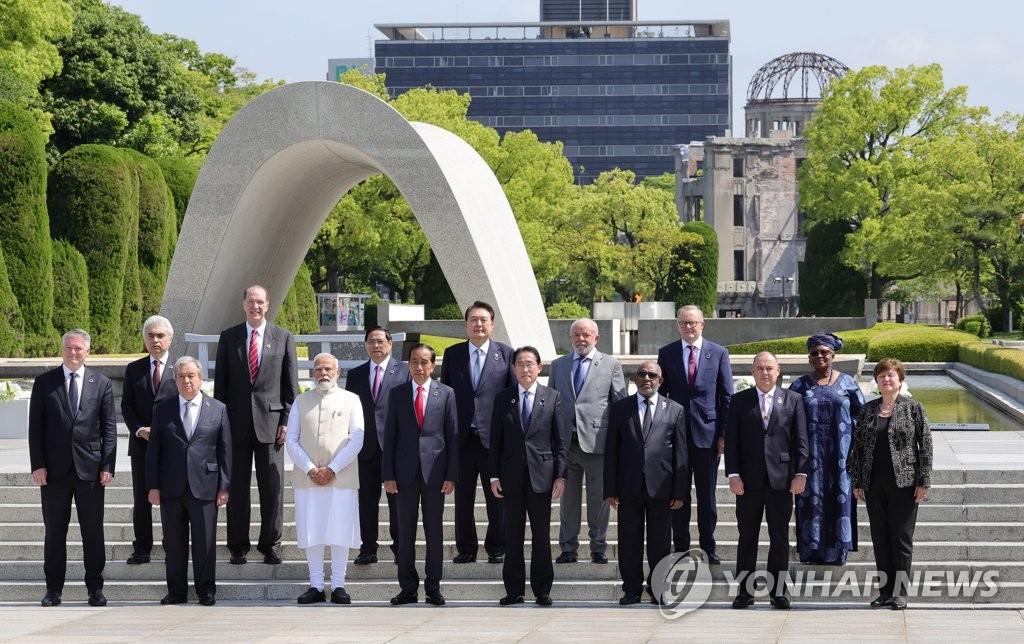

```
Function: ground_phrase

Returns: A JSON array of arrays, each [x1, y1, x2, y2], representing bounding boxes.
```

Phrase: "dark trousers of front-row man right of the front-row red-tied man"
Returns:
[[502, 471, 555, 597]]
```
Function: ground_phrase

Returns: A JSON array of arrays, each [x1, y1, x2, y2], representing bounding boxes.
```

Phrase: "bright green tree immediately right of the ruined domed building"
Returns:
[[799, 65, 978, 317]]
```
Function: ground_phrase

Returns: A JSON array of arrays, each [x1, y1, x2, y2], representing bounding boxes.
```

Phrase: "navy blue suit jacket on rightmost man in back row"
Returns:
[[657, 338, 732, 448]]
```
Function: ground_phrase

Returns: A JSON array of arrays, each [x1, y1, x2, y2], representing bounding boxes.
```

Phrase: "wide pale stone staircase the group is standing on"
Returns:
[[0, 470, 1024, 608]]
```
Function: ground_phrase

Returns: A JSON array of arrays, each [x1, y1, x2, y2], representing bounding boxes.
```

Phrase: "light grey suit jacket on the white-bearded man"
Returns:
[[548, 351, 626, 454]]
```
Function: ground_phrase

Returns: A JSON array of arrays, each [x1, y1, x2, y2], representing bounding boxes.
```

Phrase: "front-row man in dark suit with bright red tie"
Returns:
[[382, 344, 459, 606]]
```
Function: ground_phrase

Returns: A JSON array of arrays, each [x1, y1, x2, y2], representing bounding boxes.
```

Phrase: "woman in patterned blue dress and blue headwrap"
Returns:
[[790, 334, 864, 565]]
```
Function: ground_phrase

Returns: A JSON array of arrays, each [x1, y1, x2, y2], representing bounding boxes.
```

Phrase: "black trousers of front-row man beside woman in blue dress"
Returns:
[[736, 477, 793, 597]]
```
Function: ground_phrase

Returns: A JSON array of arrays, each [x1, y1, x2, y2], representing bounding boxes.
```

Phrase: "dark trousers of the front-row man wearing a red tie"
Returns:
[[396, 467, 444, 593]]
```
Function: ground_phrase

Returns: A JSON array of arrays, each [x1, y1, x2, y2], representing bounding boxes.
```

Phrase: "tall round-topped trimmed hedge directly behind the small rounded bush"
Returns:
[[47, 144, 134, 353]]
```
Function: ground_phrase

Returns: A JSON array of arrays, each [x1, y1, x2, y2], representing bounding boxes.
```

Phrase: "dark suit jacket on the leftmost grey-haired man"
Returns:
[[29, 366, 118, 481]]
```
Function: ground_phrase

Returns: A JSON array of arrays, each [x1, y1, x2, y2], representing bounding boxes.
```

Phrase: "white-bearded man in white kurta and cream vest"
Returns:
[[285, 353, 364, 604]]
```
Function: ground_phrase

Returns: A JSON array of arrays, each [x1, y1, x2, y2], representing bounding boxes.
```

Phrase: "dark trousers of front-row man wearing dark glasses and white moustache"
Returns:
[[618, 484, 674, 595]]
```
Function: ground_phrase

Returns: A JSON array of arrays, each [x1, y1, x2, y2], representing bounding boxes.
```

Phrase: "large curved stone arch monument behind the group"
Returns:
[[161, 81, 555, 358]]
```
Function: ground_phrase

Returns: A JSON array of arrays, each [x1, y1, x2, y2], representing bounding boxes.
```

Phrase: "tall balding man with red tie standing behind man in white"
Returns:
[[213, 285, 299, 564]]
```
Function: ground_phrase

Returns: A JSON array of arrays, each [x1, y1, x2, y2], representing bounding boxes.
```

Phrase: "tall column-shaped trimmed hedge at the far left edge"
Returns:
[[0, 99, 59, 356]]
